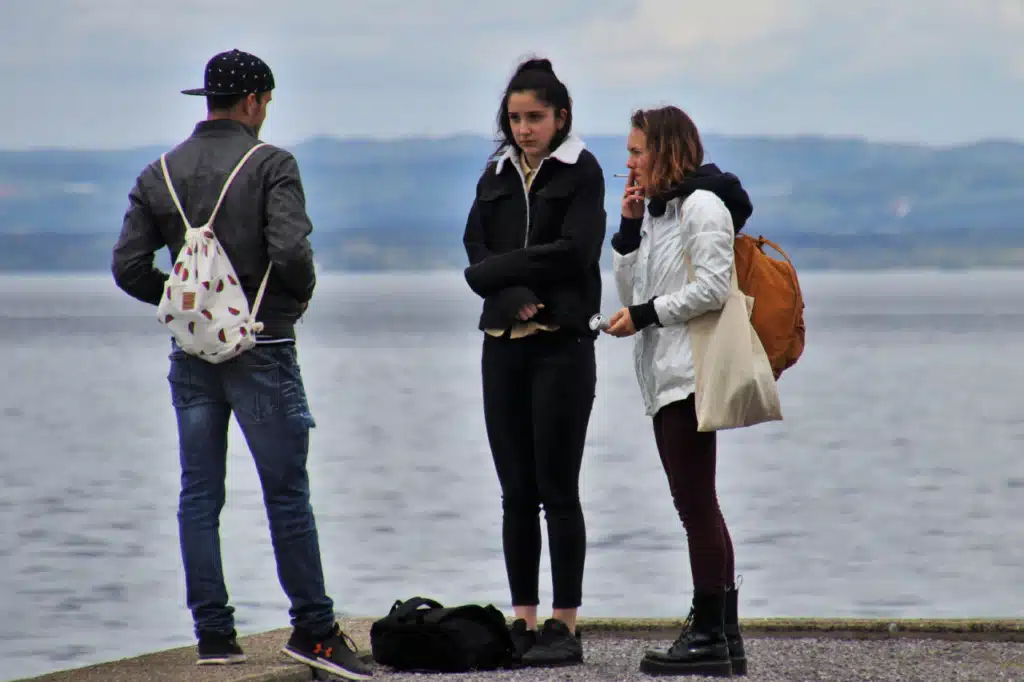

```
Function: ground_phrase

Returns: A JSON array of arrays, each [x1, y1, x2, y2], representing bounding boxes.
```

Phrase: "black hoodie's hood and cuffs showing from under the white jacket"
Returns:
[[611, 164, 754, 331]]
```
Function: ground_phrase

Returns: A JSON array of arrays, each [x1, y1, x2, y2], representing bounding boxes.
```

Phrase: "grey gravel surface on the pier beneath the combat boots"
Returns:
[[364, 638, 1024, 682]]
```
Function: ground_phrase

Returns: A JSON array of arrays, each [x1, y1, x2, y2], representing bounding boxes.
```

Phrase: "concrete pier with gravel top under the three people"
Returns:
[[12, 619, 1024, 682]]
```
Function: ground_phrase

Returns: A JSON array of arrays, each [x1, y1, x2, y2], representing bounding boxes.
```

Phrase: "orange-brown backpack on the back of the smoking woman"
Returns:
[[733, 235, 805, 379]]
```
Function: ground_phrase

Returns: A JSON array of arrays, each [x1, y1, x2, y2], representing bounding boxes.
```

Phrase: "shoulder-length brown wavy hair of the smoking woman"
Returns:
[[630, 106, 703, 196]]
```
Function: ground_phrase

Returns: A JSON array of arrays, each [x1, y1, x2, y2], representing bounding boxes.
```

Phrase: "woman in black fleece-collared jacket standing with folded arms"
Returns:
[[463, 59, 606, 666]]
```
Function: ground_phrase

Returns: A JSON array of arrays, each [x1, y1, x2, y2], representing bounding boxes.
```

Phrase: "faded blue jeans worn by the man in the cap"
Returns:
[[168, 342, 335, 636]]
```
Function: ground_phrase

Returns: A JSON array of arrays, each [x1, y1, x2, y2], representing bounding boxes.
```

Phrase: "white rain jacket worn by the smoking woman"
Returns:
[[612, 189, 735, 417]]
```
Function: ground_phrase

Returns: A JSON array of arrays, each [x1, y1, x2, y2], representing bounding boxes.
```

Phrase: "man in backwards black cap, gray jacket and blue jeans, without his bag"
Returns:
[[112, 50, 371, 680]]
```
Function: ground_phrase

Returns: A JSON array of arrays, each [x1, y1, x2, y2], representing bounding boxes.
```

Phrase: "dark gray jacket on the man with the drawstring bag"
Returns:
[[111, 120, 316, 338]]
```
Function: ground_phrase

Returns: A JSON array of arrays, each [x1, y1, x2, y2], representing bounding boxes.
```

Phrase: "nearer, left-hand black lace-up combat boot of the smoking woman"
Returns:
[[640, 591, 732, 677]]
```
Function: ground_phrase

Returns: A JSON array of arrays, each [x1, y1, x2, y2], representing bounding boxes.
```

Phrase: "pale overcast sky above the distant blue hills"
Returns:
[[0, 0, 1024, 148]]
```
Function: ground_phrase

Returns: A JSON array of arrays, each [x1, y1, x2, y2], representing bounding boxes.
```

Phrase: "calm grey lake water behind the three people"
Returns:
[[0, 271, 1024, 680]]
